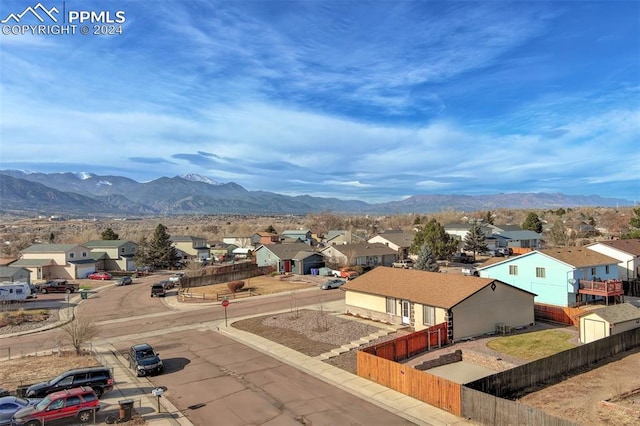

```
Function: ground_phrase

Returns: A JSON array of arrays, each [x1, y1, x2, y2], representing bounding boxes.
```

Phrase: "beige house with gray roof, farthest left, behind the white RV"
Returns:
[[11, 244, 96, 282]]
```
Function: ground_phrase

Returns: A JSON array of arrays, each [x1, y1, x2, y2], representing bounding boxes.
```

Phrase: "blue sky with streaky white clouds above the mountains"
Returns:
[[0, 0, 640, 202]]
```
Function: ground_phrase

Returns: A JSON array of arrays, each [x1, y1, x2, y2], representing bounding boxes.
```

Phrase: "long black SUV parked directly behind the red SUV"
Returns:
[[24, 367, 113, 398]]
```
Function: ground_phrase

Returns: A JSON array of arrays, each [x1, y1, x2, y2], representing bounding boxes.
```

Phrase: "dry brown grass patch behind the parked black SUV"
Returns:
[[0, 351, 100, 391]]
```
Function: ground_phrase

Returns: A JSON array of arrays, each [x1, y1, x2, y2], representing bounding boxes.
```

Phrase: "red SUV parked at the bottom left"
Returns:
[[11, 387, 100, 426]]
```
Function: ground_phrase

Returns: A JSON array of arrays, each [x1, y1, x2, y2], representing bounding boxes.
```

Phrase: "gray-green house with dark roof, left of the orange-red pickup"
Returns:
[[254, 243, 324, 275]]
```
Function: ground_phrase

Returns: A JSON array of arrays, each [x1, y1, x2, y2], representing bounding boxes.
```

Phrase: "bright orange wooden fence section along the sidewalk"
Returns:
[[357, 350, 461, 416]]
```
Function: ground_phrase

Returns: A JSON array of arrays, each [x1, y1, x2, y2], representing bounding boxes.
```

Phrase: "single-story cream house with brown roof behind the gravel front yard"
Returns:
[[341, 267, 535, 340]]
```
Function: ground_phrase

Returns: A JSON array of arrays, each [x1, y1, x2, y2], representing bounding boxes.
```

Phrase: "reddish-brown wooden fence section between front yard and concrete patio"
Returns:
[[362, 323, 448, 361]]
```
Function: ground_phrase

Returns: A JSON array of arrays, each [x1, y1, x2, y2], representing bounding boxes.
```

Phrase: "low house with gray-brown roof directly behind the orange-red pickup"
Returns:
[[321, 243, 398, 267]]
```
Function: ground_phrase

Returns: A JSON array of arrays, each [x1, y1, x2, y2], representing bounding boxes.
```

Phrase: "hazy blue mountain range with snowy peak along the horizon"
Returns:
[[0, 170, 633, 216]]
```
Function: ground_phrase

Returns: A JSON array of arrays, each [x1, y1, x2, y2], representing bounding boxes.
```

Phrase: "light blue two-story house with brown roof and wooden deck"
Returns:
[[478, 247, 624, 307]]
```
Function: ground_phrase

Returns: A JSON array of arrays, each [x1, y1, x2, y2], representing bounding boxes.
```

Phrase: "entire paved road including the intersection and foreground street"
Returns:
[[0, 276, 420, 426]]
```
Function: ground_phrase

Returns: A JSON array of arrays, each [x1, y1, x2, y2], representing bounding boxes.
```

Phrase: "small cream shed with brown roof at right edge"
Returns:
[[580, 303, 640, 343]]
